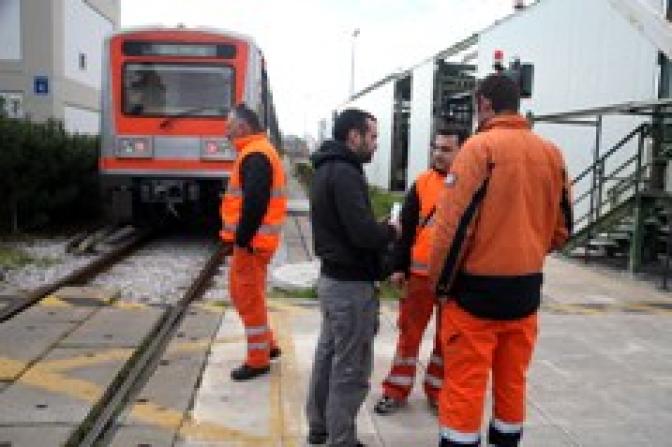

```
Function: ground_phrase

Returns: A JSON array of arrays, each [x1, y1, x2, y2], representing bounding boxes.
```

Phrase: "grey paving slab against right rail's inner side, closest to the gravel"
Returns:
[[60, 307, 165, 348]]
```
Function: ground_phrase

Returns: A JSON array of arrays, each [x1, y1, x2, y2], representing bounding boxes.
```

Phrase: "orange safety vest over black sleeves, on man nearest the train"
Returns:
[[220, 133, 287, 251]]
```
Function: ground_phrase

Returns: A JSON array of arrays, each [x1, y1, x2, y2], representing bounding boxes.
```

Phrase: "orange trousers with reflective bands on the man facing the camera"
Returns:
[[383, 274, 443, 400]]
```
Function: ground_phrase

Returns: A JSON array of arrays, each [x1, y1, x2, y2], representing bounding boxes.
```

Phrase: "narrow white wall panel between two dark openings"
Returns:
[[406, 60, 435, 189]]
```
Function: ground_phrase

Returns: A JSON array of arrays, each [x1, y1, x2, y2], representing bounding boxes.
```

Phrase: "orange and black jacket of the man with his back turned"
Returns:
[[430, 114, 572, 320]]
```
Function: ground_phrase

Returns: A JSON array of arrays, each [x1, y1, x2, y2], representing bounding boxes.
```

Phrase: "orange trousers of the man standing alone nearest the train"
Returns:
[[229, 247, 277, 368]]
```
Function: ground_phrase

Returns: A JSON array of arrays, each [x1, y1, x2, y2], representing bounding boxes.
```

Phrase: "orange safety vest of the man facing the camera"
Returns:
[[411, 169, 445, 276]]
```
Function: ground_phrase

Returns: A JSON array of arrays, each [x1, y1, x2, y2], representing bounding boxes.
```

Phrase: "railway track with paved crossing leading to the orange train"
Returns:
[[0, 234, 234, 447]]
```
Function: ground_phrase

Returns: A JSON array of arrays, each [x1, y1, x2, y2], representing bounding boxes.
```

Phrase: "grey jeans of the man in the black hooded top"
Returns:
[[306, 276, 378, 447]]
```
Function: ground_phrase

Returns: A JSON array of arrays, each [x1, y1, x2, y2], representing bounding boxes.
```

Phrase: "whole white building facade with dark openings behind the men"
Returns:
[[325, 0, 672, 194]]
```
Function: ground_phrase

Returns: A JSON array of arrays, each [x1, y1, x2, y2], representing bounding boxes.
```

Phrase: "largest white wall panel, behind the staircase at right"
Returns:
[[478, 0, 660, 228]]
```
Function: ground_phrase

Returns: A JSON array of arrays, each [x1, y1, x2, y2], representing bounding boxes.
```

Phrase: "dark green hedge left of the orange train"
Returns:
[[0, 116, 99, 232]]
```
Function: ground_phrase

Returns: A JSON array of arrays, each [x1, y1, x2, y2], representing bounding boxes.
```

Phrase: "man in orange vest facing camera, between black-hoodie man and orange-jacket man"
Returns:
[[374, 124, 468, 415]]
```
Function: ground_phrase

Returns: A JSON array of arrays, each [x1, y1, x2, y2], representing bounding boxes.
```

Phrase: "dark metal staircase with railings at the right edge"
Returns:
[[530, 100, 672, 286]]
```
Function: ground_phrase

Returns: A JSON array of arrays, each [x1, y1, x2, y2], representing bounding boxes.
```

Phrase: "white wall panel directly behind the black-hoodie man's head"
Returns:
[[344, 81, 394, 189]]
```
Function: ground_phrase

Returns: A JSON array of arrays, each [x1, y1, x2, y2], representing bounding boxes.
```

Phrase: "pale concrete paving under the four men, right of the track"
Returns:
[[172, 252, 672, 447]]
